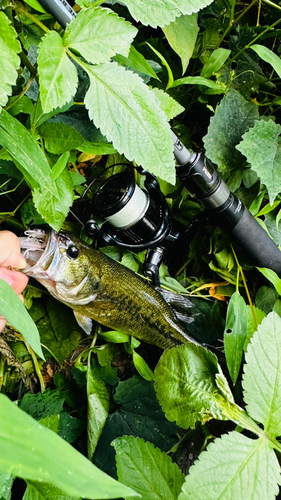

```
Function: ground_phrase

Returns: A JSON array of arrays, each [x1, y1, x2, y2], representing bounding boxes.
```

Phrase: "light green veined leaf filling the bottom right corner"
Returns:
[[178, 432, 280, 500]]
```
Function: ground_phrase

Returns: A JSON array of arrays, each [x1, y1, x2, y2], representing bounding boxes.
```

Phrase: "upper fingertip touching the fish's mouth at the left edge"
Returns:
[[0, 231, 26, 269]]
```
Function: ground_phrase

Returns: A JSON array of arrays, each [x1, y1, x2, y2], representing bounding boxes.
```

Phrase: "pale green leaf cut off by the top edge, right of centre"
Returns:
[[123, 0, 212, 28]]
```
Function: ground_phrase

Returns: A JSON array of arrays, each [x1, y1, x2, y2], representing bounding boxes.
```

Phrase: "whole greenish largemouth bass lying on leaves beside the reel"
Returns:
[[21, 229, 198, 349]]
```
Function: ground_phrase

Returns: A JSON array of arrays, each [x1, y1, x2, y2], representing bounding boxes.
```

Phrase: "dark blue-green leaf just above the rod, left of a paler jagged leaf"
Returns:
[[203, 89, 258, 172]]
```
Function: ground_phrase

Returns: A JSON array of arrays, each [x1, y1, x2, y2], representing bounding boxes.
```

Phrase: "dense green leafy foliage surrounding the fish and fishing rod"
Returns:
[[0, 0, 281, 500]]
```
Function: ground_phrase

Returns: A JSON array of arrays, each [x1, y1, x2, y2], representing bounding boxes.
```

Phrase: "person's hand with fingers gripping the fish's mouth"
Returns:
[[0, 231, 28, 332]]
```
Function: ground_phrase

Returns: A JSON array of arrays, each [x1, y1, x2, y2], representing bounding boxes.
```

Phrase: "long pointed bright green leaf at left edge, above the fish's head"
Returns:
[[0, 110, 57, 196]]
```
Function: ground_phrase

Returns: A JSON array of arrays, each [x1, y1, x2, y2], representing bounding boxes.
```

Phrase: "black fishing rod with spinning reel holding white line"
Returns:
[[32, 0, 281, 284]]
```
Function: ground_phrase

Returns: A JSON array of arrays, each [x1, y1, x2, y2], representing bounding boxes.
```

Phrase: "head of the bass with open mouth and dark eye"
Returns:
[[20, 228, 100, 306]]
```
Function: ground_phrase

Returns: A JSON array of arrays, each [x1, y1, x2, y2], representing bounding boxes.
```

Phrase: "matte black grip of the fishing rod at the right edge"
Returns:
[[230, 207, 281, 277]]
